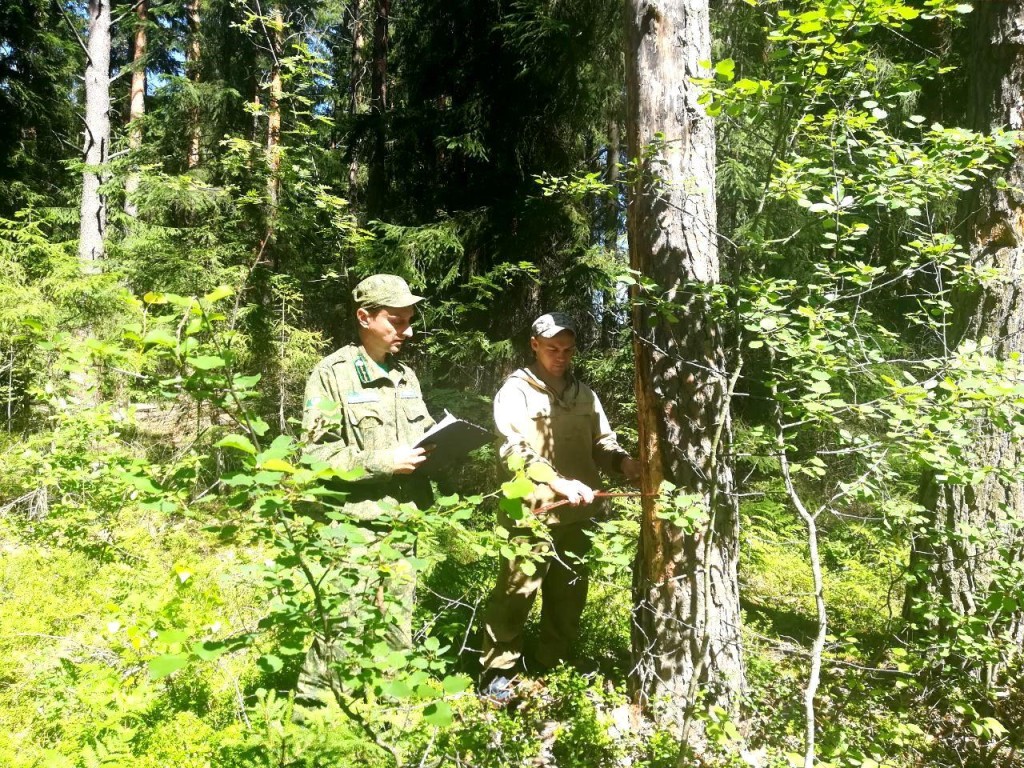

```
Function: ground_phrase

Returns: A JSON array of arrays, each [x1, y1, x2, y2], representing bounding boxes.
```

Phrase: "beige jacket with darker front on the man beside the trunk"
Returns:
[[495, 368, 628, 525]]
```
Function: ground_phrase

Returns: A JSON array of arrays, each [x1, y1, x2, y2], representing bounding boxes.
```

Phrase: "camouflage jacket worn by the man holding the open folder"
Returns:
[[302, 344, 434, 520]]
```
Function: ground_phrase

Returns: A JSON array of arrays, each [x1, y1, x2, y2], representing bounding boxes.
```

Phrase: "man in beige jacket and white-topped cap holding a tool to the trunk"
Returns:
[[481, 312, 640, 702]]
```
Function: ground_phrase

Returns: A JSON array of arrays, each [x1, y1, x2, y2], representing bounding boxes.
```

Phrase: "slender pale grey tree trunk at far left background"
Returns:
[[78, 0, 111, 272]]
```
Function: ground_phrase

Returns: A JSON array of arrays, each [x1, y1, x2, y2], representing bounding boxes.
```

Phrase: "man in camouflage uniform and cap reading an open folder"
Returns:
[[296, 274, 434, 706]]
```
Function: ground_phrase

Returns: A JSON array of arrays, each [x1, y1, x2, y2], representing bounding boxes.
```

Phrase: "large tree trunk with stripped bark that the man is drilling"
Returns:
[[626, 0, 743, 740]]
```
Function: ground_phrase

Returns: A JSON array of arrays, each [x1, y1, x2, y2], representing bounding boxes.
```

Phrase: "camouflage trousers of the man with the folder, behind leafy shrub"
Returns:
[[295, 527, 416, 708]]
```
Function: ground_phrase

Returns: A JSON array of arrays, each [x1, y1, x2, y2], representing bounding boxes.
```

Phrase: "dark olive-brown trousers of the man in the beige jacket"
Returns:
[[480, 520, 592, 673]]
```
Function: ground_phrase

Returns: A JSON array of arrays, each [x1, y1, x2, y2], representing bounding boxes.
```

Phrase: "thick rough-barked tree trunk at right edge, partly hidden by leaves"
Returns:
[[906, 0, 1024, 672]]
